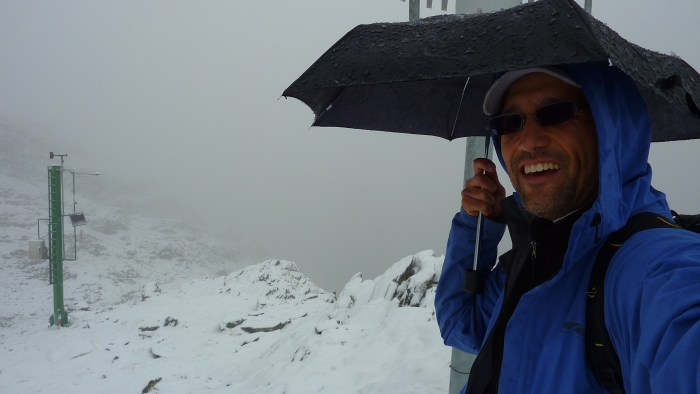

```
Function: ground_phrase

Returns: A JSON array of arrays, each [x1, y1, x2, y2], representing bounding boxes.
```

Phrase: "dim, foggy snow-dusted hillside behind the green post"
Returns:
[[0, 121, 250, 328]]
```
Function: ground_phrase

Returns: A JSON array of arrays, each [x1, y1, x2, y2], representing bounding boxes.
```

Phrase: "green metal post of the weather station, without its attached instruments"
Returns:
[[49, 166, 68, 327]]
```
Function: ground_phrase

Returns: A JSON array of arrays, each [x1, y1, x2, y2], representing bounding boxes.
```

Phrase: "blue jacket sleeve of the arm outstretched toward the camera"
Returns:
[[605, 229, 700, 393]]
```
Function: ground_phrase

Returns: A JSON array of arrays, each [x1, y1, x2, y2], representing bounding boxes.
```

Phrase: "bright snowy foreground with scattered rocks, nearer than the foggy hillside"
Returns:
[[0, 251, 449, 394]]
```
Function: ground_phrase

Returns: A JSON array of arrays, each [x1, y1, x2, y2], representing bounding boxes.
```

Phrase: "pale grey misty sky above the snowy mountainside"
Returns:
[[0, 0, 700, 290]]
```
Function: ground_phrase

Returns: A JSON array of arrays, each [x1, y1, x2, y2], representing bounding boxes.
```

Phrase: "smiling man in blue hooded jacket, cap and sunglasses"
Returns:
[[435, 64, 700, 394]]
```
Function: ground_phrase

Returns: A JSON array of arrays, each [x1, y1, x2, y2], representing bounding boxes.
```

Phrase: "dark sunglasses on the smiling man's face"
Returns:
[[488, 101, 589, 137]]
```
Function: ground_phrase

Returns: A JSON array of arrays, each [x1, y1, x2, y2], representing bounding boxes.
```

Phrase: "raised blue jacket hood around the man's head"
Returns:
[[494, 63, 671, 252]]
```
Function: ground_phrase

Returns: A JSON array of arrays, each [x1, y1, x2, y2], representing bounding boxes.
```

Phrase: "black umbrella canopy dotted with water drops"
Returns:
[[283, 0, 700, 141]]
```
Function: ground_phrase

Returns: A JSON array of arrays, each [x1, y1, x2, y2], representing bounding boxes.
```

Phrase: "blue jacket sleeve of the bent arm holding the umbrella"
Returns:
[[435, 209, 506, 353]]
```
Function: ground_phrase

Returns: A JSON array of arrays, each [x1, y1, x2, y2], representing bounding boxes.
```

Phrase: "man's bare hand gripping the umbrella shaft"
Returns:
[[462, 159, 506, 220]]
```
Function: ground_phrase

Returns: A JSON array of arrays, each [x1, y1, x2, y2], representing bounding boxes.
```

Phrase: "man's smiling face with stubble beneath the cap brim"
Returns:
[[501, 73, 598, 220]]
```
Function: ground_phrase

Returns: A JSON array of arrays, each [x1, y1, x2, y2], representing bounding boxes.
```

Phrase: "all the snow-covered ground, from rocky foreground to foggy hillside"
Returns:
[[0, 125, 450, 394]]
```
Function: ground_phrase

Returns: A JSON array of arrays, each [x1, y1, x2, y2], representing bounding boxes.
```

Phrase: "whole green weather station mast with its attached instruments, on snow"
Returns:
[[29, 152, 100, 327]]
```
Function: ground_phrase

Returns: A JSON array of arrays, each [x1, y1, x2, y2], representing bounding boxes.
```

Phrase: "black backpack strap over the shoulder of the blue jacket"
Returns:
[[586, 212, 680, 394]]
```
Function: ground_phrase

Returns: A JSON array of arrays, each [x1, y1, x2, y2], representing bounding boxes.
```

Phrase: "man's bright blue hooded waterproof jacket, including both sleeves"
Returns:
[[435, 64, 700, 394]]
